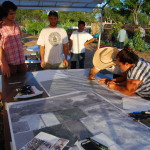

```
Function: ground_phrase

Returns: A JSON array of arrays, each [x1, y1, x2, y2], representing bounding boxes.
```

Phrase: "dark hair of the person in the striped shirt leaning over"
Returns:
[[116, 46, 139, 64]]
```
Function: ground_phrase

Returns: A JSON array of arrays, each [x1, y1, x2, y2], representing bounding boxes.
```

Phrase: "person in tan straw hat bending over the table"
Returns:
[[88, 47, 121, 80]]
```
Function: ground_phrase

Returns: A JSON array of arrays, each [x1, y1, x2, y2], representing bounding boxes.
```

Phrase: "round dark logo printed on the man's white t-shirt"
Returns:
[[48, 32, 61, 46]]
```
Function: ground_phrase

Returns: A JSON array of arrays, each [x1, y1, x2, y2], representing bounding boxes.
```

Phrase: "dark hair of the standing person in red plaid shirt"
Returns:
[[2, 1, 17, 16]]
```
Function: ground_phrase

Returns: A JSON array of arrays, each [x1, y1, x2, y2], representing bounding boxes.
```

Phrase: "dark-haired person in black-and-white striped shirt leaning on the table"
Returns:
[[99, 48, 150, 97]]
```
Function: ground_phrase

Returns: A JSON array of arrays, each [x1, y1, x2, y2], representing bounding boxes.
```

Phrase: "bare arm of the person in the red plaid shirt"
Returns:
[[0, 46, 10, 77]]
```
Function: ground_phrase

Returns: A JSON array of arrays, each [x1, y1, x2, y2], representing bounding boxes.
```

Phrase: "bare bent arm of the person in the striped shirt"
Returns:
[[108, 79, 142, 96]]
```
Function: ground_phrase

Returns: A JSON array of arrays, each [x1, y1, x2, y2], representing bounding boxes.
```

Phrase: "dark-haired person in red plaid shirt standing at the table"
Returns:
[[0, 1, 27, 77]]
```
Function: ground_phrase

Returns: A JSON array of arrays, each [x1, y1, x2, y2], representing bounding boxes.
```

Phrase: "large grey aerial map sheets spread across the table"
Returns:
[[7, 70, 150, 150]]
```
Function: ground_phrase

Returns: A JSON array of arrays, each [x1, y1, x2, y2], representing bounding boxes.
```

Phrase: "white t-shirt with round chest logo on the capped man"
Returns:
[[37, 26, 68, 64]]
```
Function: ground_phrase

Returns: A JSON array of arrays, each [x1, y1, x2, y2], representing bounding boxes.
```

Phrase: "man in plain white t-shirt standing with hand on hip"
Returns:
[[69, 21, 95, 69]]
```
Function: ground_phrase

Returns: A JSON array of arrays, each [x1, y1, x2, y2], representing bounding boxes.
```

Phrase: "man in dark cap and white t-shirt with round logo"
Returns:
[[37, 11, 68, 69]]
